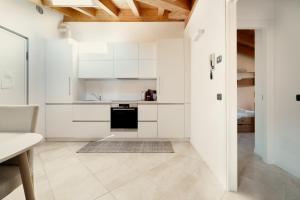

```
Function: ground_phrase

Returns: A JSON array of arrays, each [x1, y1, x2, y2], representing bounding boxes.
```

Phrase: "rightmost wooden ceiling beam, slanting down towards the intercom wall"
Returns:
[[137, 0, 190, 13]]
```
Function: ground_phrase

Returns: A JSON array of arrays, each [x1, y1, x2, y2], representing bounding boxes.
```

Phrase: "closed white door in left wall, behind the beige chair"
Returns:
[[0, 26, 28, 105]]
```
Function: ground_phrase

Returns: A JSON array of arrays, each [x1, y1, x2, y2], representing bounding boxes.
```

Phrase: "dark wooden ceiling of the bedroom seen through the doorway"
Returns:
[[237, 30, 255, 57]]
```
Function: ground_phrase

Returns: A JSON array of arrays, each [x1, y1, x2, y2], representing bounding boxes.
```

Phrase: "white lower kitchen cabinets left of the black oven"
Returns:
[[46, 104, 110, 140]]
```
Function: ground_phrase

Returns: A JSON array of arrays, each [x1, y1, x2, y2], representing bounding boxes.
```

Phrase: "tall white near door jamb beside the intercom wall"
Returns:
[[226, 0, 238, 191]]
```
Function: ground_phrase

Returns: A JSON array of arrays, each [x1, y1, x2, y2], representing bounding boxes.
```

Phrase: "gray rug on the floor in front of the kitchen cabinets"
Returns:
[[77, 141, 174, 153]]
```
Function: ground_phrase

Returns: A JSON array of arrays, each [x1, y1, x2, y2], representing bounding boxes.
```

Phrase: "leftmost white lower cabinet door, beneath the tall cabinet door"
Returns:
[[46, 105, 73, 138]]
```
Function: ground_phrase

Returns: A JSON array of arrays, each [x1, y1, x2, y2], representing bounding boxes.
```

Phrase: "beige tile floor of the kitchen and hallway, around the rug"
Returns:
[[5, 134, 300, 200]]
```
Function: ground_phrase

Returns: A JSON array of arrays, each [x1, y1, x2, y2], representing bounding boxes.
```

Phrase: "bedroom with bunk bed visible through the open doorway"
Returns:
[[237, 30, 255, 171]]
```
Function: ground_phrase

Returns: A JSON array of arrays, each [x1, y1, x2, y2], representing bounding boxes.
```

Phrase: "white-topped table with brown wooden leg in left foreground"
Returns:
[[0, 133, 43, 200]]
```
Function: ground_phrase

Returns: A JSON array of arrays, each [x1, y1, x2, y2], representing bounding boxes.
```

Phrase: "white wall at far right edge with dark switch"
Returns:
[[274, 0, 300, 177]]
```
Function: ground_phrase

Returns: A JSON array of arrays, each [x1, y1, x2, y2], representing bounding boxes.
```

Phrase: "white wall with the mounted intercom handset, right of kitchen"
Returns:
[[186, 0, 226, 188]]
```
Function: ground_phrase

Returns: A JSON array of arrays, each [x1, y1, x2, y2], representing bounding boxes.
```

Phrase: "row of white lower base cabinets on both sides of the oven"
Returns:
[[46, 104, 185, 140]]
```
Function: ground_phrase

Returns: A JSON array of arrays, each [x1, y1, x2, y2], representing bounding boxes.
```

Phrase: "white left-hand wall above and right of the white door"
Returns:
[[0, 0, 61, 134]]
